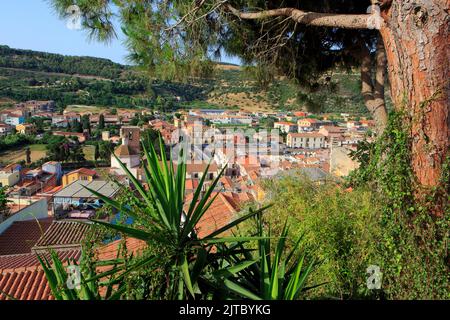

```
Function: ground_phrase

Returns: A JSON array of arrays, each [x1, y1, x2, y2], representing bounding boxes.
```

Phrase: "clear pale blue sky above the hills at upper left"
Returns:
[[0, 0, 239, 64]]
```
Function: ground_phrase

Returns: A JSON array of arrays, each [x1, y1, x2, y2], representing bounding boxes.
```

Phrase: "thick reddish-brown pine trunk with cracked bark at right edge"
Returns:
[[380, 0, 450, 187]]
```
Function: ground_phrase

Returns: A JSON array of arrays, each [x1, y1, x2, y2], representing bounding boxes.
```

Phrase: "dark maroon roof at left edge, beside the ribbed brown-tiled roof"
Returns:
[[0, 219, 52, 256]]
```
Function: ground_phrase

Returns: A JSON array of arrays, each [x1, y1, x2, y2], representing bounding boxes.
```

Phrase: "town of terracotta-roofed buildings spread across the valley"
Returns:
[[0, 101, 374, 299]]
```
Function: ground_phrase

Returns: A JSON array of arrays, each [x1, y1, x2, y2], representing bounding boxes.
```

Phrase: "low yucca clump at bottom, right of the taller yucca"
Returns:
[[205, 214, 323, 300]]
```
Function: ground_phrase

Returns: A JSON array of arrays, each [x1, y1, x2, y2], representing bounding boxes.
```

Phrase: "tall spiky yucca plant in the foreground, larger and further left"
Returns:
[[79, 138, 265, 299]]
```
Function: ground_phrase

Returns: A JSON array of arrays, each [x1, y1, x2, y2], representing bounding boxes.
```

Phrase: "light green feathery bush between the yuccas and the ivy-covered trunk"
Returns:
[[246, 172, 381, 299]]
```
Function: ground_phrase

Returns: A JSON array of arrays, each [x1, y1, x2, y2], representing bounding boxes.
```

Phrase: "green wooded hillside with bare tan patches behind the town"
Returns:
[[0, 46, 380, 115]]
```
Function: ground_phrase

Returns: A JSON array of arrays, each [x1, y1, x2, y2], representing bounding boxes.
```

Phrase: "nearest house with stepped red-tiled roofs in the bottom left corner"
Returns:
[[0, 215, 84, 300]]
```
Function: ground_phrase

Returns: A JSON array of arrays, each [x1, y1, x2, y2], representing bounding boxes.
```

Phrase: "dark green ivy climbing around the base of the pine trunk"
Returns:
[[348, 112, 450, 299]]
